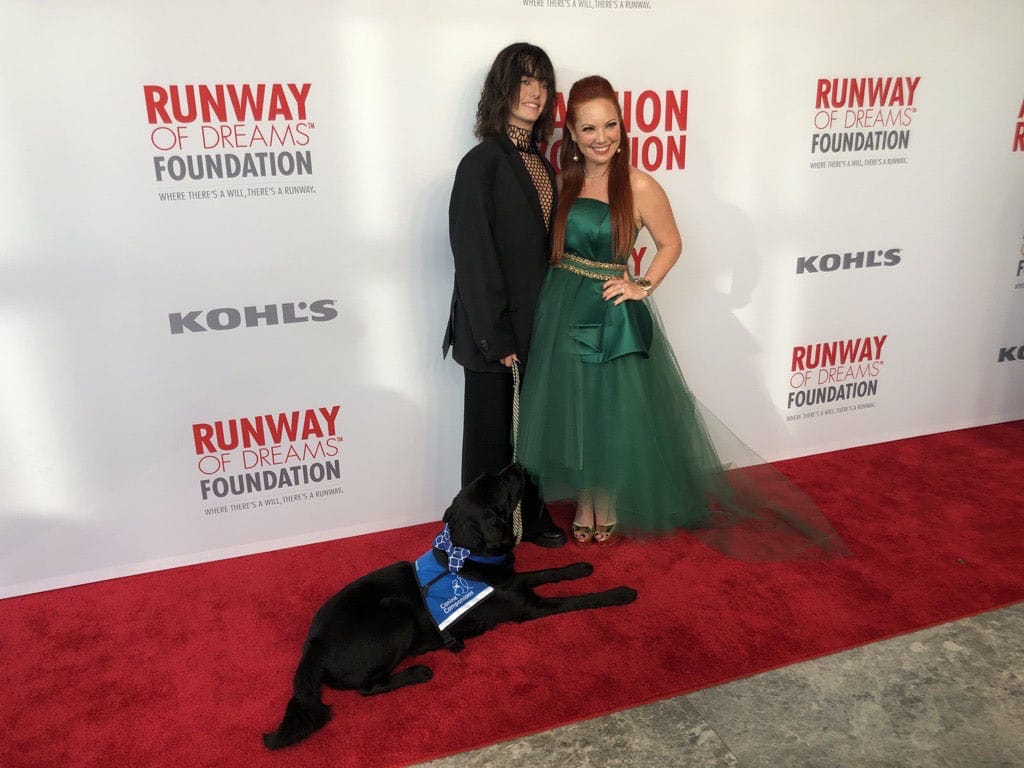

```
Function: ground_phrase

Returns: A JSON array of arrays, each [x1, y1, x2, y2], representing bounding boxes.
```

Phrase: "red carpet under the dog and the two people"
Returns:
[[0, 422, 1024, 768]]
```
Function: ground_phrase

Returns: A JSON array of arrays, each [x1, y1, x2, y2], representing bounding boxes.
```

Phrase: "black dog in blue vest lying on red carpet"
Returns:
[[263, 464, 637, 750]]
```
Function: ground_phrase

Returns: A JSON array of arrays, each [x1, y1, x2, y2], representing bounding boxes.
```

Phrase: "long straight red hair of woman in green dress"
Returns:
[[551, 75, 636, 264]]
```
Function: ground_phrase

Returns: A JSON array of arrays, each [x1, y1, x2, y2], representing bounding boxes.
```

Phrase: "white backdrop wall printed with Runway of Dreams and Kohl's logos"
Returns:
[[0, 0, 1024, 596]]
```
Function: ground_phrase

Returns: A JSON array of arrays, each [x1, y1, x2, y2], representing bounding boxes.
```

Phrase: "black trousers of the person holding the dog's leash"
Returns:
[[462, 370, 550, 538]]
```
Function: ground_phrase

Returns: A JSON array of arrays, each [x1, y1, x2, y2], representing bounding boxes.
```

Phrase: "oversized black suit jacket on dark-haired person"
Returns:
[[441, 136, 557, 372]]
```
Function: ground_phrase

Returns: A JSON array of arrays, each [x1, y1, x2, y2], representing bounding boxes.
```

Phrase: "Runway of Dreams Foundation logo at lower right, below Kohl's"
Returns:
[[785, 334, 889, 421]]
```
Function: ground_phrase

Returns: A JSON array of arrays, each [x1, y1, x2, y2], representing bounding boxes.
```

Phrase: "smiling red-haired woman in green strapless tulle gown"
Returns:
[[517, 76, 843, 560]]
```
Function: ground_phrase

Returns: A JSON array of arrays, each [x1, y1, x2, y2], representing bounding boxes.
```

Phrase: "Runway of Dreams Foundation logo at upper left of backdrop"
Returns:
[[142, 83, 315, 200]]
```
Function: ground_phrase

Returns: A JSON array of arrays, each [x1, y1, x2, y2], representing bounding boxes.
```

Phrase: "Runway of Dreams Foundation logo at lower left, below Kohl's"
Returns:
[[191, 406, 342, 515]]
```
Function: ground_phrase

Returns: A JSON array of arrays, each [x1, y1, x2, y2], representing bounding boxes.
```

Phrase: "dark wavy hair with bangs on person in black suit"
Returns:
[[474, 43, 555, 143]]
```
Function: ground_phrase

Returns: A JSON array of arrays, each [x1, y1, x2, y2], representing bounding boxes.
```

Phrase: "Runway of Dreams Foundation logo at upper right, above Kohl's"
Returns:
[[811, 76, 921, 168]]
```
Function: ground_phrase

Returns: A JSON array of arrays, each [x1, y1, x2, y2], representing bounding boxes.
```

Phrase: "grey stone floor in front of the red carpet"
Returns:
[[420, 603, 1024, 768]]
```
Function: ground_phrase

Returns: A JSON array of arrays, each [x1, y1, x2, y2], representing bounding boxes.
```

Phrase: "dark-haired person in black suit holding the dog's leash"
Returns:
[[442, 43, 565, 547]]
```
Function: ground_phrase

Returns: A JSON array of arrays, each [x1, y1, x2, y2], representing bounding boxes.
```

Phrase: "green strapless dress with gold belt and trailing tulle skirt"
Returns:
[[516, 198, 844, 560]]
